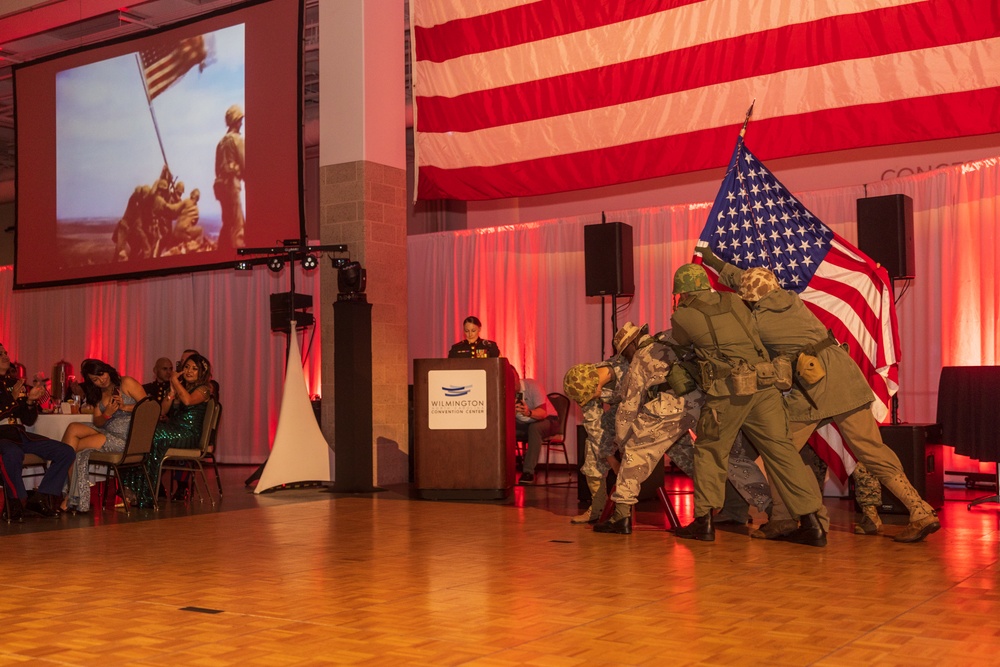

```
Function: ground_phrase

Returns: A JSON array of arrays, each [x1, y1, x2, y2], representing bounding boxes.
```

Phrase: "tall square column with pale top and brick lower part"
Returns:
[[319, 0, 409, 485]]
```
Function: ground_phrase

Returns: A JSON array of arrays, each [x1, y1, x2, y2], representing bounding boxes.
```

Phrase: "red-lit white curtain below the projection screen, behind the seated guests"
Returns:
[[0, 266, 320, 463]]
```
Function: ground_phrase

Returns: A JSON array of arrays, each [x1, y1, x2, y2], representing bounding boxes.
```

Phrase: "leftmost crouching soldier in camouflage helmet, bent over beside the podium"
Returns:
[[563, 354, 628, 524]]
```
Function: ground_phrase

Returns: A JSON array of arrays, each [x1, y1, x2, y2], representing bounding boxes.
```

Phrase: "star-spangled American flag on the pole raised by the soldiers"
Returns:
[[698, 138, 899, 481]]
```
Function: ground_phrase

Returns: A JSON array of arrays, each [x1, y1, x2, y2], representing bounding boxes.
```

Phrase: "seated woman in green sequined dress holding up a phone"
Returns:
[[125, 354, 212, 507]]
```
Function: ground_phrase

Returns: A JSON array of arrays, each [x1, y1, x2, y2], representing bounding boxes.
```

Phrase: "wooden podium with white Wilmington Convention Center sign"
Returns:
[[413, 357, 515, 500]]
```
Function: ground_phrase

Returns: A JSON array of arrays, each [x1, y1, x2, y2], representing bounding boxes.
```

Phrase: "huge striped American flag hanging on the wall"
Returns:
[[410, 0, 1000, 200]]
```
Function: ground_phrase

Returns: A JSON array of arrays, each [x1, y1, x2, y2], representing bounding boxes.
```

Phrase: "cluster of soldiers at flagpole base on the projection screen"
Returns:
[[111, 166, 214, 262]]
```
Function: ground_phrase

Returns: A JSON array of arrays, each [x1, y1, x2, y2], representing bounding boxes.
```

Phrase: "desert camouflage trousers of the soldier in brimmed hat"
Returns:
[[611, 412, 690, 505]]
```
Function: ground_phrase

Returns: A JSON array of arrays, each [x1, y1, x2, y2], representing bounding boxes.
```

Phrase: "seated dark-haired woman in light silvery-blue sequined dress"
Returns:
[[63, 359, 146, 513]]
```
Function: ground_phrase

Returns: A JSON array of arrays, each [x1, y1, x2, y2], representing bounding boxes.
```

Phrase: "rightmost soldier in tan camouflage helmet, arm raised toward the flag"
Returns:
[[699, 248, 941, 542]]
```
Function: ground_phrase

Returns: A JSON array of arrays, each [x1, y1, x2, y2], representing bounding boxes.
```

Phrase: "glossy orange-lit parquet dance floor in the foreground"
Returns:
[[0, 468, 1000, 667]]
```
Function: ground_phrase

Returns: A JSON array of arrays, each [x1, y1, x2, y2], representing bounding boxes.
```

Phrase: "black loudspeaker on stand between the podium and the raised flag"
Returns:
[[583, 222, 635, 296]]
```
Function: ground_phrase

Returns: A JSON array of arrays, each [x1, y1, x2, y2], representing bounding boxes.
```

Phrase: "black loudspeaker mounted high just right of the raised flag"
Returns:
[[858, 195, 916, 279]]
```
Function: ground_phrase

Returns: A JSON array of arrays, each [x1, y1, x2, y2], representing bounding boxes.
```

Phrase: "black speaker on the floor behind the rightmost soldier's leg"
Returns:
[[860, 424, 944, 514]]
